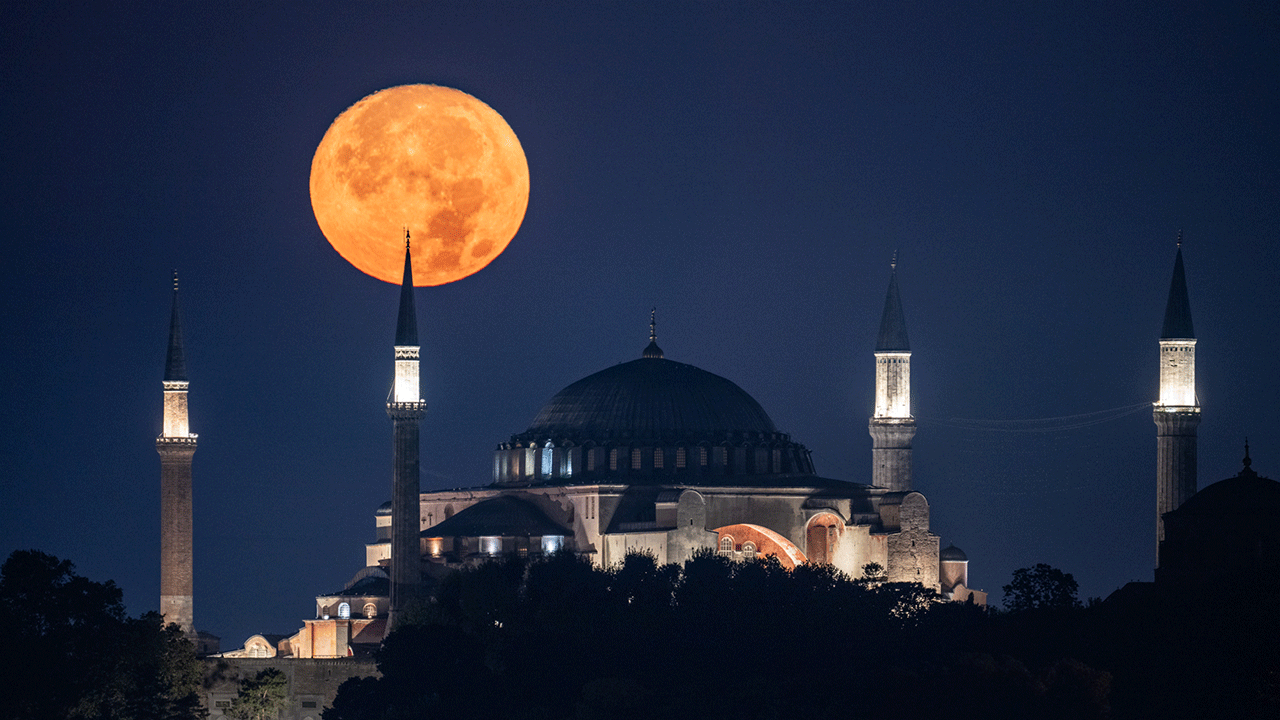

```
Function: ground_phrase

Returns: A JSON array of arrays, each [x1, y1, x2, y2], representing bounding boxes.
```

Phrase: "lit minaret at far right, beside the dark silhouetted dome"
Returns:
[[1152, 233, 1201, 562]]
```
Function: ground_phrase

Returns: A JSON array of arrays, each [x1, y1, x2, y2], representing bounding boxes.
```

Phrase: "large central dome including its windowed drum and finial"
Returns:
[[494, 336, 813, 484]]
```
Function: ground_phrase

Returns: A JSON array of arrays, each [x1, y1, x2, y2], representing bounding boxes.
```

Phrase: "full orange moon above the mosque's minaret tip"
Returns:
[[311, 85, 529, 286]]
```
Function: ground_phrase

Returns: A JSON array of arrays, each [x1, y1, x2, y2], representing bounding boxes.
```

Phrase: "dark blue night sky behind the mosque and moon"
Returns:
[[0, 1, 1280, 648]]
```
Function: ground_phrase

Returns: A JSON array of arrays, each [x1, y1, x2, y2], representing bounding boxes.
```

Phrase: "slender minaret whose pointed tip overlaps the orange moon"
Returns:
[[387, 231, 426, 633]]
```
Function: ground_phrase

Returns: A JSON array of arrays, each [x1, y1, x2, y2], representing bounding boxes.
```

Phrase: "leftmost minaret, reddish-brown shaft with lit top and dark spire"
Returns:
[[156, 270, 196, 635]]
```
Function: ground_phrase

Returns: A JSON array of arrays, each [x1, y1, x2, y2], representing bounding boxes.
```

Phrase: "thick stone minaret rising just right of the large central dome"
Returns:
[[869, 252, 915, 492]]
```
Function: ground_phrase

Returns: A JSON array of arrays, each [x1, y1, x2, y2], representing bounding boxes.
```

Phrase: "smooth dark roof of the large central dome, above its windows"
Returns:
[[527, 357, 777, 442]]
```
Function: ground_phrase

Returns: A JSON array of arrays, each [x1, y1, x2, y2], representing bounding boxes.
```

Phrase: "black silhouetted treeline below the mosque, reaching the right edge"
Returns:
[[324, 553, 1280, 720]]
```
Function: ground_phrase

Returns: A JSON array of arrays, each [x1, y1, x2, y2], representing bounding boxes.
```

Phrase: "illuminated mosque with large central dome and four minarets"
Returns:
[[170, 242, 1280, 659]]
